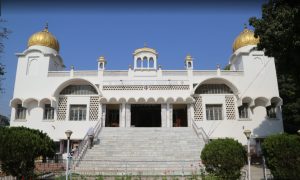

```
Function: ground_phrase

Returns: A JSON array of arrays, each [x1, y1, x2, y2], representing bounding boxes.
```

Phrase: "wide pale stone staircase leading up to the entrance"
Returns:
[[75, 127, 205, 175]]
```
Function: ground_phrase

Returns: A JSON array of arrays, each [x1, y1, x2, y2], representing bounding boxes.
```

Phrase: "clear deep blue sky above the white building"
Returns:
[[0, 0, 263, 116]]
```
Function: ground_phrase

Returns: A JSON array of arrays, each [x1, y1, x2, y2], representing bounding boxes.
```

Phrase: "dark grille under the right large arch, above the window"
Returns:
[[196, 84, 233, 94]]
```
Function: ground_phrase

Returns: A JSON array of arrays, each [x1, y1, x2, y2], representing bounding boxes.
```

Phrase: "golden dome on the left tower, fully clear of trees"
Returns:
[[27, 25, 59, 52]]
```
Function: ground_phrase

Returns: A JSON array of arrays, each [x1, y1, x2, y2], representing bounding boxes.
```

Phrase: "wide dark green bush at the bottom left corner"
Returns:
[[0, 127, 55, 179]]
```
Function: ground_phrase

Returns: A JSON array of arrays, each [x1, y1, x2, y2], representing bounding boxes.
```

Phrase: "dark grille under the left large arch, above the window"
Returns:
[[60, 85, 98, 95]]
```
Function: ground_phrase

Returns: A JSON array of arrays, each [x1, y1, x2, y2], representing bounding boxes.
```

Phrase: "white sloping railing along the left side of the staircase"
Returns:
[[73, 118, 103, 168]]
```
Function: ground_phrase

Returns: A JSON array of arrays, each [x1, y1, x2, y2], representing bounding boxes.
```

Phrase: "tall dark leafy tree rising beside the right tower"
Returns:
[[249, 0, 300, 133]]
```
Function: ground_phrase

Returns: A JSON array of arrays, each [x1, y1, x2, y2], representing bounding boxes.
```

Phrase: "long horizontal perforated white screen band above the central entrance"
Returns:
[[103, 85, 189, 91]]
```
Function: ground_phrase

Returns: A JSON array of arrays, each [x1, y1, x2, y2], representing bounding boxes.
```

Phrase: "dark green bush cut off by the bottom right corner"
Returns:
[[262, 134, 300, 179]]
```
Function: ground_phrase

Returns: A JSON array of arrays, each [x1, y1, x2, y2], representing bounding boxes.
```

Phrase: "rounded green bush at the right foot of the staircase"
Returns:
[[201, 138, 247, 179]]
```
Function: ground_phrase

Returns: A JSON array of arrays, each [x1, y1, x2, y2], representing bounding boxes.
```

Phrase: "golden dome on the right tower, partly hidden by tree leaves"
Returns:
[[232, 27, 259, 52]]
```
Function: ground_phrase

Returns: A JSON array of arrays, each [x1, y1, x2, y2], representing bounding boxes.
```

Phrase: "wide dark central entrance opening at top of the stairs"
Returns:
[[131, 104, 161, 127]]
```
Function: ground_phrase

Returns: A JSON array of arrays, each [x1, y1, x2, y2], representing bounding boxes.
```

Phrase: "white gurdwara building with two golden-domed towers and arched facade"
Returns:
[[10, 24, 283, 172]]
